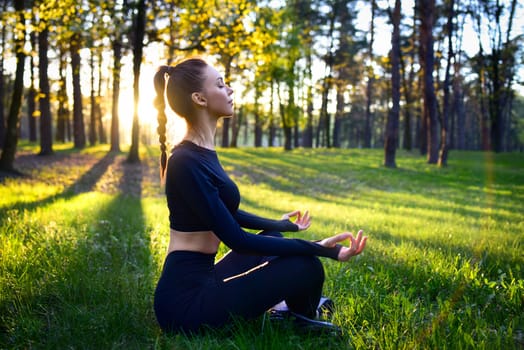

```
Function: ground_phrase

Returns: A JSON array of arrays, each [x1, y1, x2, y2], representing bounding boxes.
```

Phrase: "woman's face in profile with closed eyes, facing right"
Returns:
[[202, 66, 233, 118]]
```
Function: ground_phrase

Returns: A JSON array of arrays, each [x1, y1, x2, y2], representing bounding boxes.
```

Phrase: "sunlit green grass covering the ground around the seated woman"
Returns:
[[0, 144, 524, 349]]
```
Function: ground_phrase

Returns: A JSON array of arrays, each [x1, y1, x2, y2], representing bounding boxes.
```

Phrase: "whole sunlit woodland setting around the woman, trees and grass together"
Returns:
[[0, 0, 524, 350]]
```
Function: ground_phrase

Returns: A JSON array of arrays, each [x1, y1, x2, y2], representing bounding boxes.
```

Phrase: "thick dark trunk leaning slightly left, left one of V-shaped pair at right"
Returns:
[[419, 0, 439, 164]]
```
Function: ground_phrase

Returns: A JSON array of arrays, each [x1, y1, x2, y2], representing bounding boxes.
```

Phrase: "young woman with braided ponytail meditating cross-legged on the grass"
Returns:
[[154, 58, 367, 332]]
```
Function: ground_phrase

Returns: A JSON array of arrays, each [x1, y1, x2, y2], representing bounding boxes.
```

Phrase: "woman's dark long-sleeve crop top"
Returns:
[[166, 141, 340, 260]]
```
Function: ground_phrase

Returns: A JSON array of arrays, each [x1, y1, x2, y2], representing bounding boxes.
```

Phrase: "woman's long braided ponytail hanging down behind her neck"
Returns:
[[154, 66, 169, 180]]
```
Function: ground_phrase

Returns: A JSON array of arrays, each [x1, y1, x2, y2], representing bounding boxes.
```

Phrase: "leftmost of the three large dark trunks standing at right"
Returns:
[[384, 0, 401, 168]]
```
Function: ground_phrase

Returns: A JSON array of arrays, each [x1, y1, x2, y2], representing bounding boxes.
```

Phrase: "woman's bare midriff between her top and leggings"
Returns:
[[167, 229, 220, 254]]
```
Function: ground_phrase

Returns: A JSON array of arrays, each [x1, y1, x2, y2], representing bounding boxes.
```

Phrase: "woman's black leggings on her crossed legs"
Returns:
[[155, 231, 324, 332]]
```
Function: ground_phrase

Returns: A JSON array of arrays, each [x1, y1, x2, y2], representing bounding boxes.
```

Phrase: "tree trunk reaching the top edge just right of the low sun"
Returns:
[[127, 0, 146, 163]]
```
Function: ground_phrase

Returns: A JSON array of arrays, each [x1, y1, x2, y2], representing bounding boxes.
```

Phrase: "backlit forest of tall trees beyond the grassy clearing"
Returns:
[[0, 0, 524, 171]]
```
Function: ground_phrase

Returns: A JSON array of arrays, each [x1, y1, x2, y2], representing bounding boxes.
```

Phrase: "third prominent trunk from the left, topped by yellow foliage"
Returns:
[[71, 33, 86, 149]]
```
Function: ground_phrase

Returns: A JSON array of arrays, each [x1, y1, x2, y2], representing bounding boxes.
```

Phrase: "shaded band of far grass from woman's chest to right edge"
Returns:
[[221, 150, 524, 220]]
